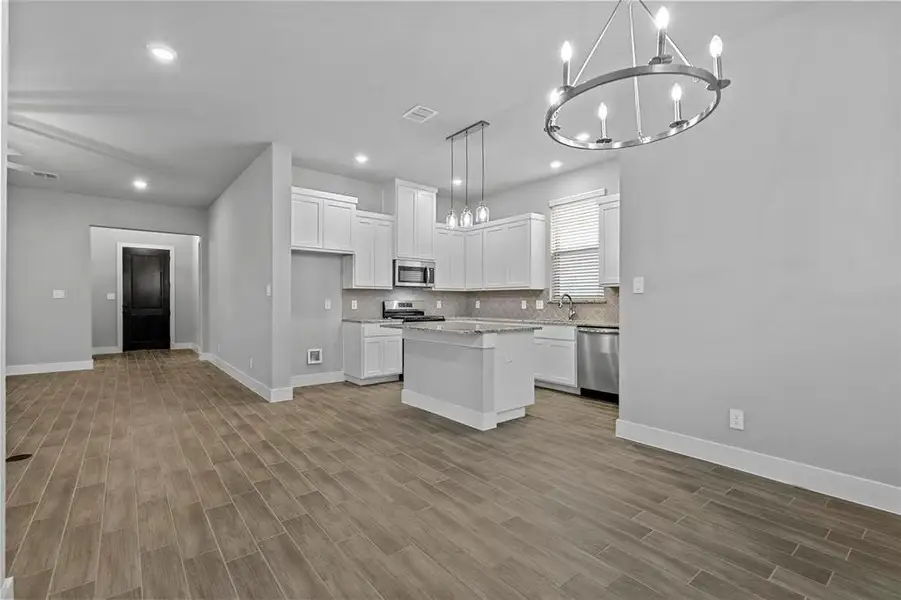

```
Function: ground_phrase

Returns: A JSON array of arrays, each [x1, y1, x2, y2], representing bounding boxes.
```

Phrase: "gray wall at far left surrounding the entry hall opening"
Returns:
[[6, 186, 206, 365]]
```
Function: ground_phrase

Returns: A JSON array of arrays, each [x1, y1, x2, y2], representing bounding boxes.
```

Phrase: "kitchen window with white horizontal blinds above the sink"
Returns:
[[551, 190, 606, 302]]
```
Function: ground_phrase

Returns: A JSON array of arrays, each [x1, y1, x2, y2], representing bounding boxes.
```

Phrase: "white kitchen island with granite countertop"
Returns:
[[383, 321, 541, 431]]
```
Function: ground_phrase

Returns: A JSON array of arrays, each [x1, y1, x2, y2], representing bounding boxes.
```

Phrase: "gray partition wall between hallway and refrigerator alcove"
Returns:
[[204, 144, 291, 388]]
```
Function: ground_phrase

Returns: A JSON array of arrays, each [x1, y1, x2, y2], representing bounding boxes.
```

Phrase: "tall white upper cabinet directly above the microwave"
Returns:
[[386, 179, 437, 260]]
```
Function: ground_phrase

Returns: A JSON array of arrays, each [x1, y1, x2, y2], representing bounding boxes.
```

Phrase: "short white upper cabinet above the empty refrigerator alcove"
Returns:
[[291, 187, 357, 254]]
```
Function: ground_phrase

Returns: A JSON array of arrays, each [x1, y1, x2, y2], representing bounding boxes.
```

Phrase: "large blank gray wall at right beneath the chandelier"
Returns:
[[620, 3, 901, 485]]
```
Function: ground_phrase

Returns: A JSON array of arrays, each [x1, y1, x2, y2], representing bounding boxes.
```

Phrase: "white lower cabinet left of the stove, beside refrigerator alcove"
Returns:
[[342, 322, 403, 385]]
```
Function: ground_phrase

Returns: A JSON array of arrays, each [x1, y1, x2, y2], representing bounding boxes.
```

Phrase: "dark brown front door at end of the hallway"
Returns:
[[122, 248, 171, 351]]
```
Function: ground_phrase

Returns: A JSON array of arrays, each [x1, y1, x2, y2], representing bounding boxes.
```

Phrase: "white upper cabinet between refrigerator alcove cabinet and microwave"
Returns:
[[343, 210, 394, 290]]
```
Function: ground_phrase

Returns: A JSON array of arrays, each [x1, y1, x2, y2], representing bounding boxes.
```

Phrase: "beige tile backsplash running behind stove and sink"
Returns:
[[342, 288, 619, 324]]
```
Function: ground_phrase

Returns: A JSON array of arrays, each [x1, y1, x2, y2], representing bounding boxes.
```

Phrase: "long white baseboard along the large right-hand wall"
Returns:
[[616, 419, 901, 515]]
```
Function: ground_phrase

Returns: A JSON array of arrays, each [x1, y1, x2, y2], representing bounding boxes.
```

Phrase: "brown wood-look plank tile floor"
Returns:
[[6, 352, 901, 600]]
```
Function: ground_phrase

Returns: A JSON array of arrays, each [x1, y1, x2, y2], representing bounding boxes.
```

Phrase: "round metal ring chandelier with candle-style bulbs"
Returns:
[[544, 0, 731, 150]]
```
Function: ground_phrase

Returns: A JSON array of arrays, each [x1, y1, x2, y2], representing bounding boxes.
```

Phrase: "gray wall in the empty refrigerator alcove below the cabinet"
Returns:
[[291, 252, 344, 375]]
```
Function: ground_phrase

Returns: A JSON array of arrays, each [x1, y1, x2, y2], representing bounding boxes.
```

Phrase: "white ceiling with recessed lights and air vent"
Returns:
[[9, 0, 791, 206]]
